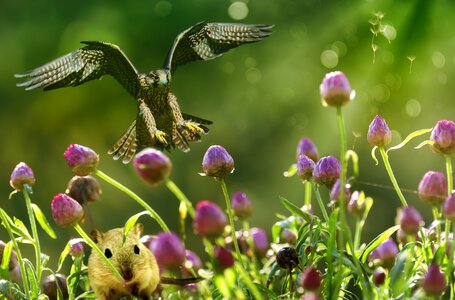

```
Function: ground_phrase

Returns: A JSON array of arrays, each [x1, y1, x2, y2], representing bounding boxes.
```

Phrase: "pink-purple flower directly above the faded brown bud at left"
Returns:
[[63, 144, 99, 176]]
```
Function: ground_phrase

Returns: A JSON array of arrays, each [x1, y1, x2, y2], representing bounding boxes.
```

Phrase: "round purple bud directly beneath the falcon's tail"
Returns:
[[133, 148, 172, 186]]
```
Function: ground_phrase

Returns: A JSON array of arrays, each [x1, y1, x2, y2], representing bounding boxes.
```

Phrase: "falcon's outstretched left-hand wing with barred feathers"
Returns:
[[15, 41, 140, 97]]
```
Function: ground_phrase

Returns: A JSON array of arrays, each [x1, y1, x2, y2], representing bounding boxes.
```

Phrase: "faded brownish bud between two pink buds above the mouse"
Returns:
[[65, 175, 101, 205]]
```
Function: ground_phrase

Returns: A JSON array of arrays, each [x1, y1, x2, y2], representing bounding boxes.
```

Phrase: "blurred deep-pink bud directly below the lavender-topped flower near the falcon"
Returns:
[[193, 201, 228, 238]]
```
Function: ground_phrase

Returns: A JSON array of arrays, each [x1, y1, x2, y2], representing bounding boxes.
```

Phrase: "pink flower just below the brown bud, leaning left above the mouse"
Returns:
[[51, 193, 84, 227]]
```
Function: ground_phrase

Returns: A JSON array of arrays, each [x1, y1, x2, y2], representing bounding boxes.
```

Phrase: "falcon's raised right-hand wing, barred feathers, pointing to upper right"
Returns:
[[164, 22, 273, 73]]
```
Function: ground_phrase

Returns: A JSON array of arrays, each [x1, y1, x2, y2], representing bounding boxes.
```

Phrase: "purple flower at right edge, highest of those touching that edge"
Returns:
[[430, 120, 455, 154]]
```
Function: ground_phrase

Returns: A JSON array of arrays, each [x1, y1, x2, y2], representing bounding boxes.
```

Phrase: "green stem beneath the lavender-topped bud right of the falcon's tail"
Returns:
[[219, 178, 262, 299]]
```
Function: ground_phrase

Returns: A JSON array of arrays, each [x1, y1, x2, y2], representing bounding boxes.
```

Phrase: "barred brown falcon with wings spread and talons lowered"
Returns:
[[16, 22, 273, 163]]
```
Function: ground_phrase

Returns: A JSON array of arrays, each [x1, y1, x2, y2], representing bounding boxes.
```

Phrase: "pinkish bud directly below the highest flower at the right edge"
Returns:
[[418, 171, 447, 205]]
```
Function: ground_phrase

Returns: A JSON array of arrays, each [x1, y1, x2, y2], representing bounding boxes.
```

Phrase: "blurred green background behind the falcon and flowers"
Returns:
[[0, 0, 455, 268]]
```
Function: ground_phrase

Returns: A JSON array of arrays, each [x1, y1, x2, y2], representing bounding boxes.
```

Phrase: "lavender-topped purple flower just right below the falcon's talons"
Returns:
[[202, 145, 234, 178]]
